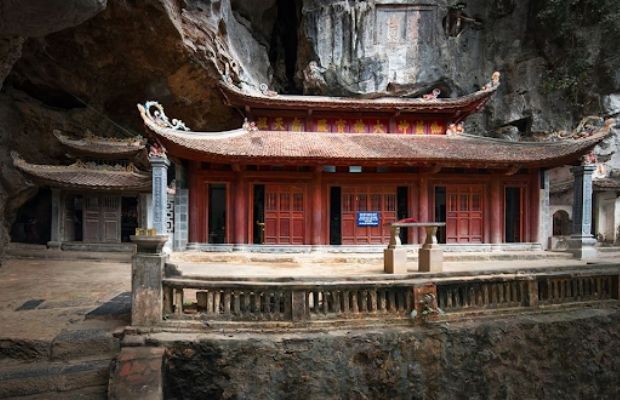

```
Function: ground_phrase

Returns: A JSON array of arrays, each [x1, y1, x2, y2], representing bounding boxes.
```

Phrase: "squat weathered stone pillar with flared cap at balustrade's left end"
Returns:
[[131, 235, 168, 326]]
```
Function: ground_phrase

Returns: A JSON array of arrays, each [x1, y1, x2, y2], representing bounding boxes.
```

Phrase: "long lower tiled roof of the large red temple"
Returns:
[[141, 104, 603, 168]]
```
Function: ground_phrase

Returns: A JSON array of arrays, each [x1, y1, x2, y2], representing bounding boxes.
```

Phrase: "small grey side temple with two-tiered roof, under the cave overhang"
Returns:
[[12, 131, 151, 250]]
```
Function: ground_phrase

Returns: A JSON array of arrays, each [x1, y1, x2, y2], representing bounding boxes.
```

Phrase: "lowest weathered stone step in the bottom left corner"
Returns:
[[0, 355, 113, 399]]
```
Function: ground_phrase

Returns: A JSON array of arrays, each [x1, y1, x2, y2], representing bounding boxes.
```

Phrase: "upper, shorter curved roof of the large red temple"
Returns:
[[220, 80, 498, 119]]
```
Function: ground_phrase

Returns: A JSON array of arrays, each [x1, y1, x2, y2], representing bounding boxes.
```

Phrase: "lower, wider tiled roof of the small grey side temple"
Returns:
[[11, 153, 151, 191]]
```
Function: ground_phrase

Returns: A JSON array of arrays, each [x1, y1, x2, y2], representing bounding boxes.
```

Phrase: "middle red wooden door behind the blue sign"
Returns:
[[341, 185, 396, 244]]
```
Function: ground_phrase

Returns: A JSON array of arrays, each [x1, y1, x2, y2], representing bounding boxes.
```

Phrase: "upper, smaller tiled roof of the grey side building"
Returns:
[[54, 130, 146, 159]]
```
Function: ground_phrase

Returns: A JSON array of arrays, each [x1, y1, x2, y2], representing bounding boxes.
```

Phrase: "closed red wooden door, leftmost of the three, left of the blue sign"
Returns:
[[264, 184, 306, 244]]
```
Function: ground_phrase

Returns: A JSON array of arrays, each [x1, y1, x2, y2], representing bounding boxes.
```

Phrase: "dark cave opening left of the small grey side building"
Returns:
[[11, 188, 52, 244]]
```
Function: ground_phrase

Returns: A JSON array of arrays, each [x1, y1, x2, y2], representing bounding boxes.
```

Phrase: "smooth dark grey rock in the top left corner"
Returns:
[[0, 0, 107, 37]]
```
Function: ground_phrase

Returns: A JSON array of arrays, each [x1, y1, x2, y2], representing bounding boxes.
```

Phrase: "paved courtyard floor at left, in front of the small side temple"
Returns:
[[0, 259, 131, 343]]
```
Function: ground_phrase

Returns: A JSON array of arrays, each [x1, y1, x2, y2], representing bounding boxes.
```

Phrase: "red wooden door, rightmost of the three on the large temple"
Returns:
[[446, 185, 484, 243]]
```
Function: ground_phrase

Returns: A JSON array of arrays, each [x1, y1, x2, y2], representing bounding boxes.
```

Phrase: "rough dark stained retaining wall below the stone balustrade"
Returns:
[[165, 309, 620, 400]]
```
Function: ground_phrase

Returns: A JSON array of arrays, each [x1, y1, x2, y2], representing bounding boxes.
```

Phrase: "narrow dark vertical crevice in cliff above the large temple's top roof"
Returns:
[[269, 0, 302, 94]]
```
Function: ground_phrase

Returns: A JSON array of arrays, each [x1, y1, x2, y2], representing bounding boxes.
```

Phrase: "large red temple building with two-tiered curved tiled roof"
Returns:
[[139, 73, 602, 249]]
